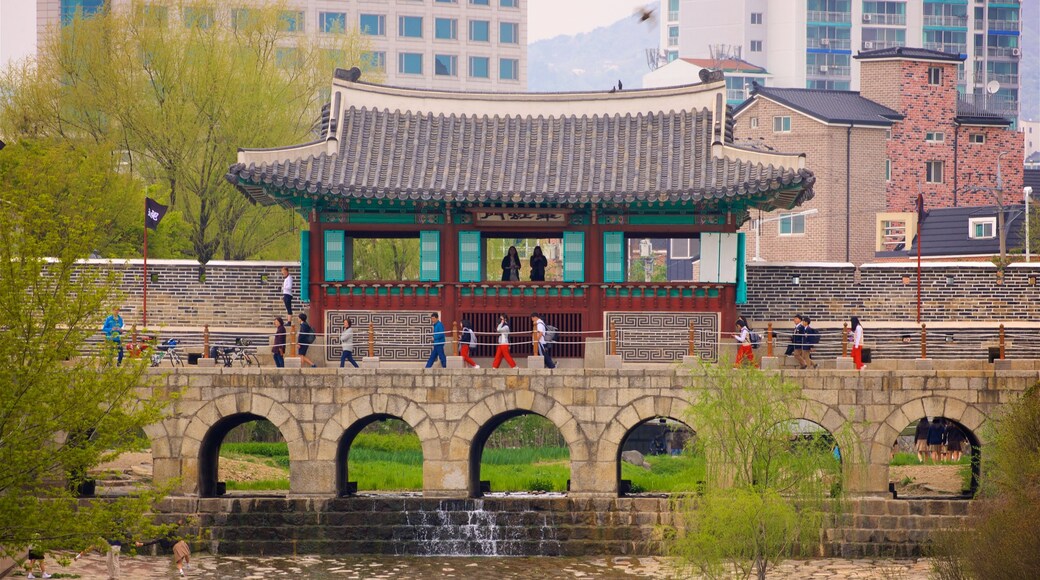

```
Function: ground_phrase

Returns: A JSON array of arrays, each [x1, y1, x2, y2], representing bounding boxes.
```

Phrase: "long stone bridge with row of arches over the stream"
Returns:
[[146, 366, 1038, 498]]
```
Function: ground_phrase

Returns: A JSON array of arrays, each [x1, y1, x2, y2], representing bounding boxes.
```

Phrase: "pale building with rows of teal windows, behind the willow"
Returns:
[[28, 0, 527, 93]]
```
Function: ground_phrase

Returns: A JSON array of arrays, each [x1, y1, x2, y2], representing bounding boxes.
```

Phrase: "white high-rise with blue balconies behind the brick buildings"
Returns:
[[660, 0, 1021, 115]]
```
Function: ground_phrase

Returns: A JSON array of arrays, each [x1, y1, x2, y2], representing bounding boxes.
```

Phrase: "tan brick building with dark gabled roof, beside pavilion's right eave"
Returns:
[[733, 86, 900, 264]]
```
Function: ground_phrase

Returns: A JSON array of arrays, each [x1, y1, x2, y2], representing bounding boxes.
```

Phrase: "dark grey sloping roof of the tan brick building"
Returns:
[[738, 85, 903, 127]]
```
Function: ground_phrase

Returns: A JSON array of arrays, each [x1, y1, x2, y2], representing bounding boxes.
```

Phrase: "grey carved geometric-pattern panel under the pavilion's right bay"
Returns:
[[604, 312, 719, 363]]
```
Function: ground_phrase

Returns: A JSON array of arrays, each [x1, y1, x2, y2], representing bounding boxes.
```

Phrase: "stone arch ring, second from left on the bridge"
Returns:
[[315, 394, 442, 495]]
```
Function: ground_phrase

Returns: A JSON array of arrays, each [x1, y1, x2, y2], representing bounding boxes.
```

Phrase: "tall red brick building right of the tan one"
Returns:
[[855, 48, 1024, 212]]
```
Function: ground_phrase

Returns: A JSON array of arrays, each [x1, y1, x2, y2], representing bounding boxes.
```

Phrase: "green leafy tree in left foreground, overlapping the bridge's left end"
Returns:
[[0, 141, 174, 554]]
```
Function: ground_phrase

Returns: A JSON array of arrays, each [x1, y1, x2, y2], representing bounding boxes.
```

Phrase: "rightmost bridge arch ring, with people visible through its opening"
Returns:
[[870, 395, 988, 494]]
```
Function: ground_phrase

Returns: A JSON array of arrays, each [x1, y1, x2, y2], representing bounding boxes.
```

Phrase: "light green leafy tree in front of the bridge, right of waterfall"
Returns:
[[670, 365, 853, 579]]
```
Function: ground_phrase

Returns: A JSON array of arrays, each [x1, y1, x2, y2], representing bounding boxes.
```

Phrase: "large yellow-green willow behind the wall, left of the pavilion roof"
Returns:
[[0, 0, 378, 263]]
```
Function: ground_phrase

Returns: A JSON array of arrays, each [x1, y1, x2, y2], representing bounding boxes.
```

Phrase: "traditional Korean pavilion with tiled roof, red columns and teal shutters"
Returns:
[[227, 69, 814, 360]]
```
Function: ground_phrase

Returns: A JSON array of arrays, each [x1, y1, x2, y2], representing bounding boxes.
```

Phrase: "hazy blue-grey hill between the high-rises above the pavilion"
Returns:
[[527, 1, 659, 93]]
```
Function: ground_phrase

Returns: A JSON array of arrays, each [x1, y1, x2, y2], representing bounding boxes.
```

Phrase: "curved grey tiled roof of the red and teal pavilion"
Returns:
[[227, 106, 815, 209]]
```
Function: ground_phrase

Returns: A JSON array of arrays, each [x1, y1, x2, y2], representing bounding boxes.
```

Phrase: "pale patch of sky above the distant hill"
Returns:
[[527, 0, 657, 44]]
